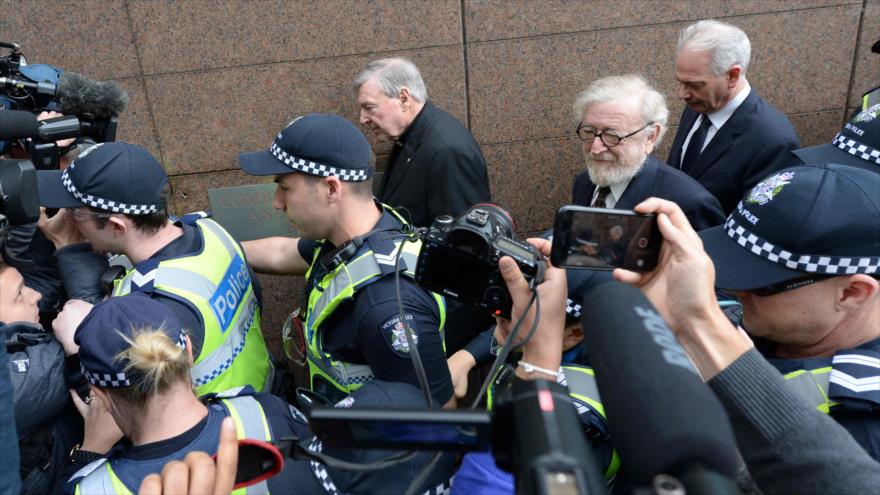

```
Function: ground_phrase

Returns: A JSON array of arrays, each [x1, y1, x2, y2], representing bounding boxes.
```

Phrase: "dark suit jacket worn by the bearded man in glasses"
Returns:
[[571, 156, 724, 230]]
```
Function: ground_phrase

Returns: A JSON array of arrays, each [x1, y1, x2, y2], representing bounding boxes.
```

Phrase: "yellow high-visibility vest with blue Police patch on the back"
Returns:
[[113, 215, 273, 396]]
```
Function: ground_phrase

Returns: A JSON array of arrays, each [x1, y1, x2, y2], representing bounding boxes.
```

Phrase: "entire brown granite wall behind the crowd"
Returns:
[[0, 0, 880, 356]]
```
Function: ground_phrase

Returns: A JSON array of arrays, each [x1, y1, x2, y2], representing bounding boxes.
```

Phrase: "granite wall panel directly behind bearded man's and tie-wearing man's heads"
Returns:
[[468, 5, 860, 143]]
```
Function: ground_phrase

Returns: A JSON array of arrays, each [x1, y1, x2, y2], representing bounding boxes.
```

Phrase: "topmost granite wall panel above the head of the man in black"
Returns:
[[129, 0, 462, 74]]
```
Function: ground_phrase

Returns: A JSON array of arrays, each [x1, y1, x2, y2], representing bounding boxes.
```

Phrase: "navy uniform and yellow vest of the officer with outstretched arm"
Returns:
[[299, 205, 452, 404]]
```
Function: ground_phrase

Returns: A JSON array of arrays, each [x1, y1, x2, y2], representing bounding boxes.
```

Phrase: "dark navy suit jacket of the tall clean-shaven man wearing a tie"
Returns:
[[666, 88, 800, 214]]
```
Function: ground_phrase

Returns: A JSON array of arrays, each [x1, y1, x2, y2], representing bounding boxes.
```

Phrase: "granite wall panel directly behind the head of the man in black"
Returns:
[[146, 46, 466, 174]]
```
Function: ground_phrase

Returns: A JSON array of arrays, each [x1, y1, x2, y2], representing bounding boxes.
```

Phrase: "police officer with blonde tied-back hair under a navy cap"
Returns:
[[65, 294, 311, 495]]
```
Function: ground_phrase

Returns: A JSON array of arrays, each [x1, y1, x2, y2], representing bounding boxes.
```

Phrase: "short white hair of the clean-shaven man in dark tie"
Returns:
[[678, 19, 752, 76]]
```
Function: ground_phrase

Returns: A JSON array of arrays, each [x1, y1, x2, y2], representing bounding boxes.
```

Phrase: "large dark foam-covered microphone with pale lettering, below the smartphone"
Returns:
[[582, 282, 737, 493]]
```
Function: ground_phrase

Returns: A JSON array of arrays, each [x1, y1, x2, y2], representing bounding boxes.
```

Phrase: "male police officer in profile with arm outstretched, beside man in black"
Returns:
[[240, 114, 454, 404]]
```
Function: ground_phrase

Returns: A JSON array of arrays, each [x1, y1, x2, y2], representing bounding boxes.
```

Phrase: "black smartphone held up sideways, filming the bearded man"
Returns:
[[550, 205, 663, 272]]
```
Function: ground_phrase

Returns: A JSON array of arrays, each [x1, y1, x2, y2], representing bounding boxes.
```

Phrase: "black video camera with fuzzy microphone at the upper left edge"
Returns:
[[0, 42, 128, 169]]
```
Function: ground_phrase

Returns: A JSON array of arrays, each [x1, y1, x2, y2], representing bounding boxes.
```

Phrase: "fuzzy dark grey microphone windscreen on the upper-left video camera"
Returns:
[[56, 71, 128, 119]]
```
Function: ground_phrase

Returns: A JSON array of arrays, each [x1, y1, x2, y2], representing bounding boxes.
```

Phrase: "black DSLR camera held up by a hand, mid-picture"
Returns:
[[415, 204, 544, 318]]
